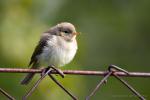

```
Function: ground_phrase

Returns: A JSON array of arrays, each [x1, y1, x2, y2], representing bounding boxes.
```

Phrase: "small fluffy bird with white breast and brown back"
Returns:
[[21, 22, 78, 85]]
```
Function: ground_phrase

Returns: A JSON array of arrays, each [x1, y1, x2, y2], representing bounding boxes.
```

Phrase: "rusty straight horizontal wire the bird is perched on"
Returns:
[[0, 68, 150, 77]]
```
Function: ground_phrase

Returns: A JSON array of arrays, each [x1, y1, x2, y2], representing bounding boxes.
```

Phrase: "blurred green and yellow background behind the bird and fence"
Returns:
[[0, 0, 150, 100]]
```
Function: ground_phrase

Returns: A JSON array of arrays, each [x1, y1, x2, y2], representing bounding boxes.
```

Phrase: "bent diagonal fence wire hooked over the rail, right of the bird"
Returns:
[[86, 65, 145, 100]]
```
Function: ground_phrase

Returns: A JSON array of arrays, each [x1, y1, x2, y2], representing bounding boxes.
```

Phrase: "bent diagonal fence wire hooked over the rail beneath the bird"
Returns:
[[22, 66, 77, 100]]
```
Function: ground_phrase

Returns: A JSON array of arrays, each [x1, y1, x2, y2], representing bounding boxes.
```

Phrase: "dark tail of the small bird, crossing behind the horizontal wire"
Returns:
[[21, 64, 38, 85]]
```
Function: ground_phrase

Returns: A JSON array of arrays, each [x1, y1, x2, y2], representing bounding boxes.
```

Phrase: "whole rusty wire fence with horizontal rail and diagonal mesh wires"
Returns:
[[0, 65, 150, 100]]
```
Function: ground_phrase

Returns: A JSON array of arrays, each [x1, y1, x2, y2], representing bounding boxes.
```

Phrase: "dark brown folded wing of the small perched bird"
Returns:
[[29, 33, 51, 66]]
